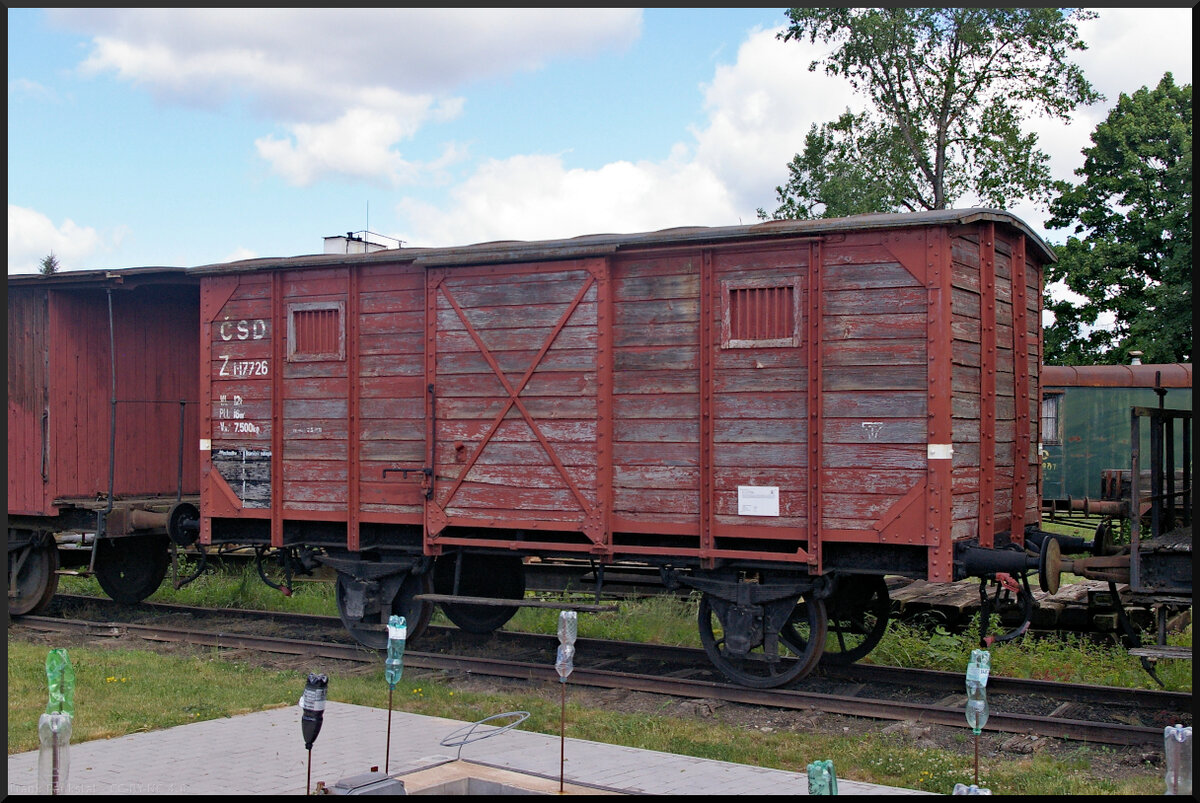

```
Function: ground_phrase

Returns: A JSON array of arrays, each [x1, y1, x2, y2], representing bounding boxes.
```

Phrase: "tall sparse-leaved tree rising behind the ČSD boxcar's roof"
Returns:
[[758, 7, 1102, 220]]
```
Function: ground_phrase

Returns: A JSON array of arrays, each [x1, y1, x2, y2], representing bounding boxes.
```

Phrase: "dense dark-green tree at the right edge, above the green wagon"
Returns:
[[1044, 73, 1192, 365]]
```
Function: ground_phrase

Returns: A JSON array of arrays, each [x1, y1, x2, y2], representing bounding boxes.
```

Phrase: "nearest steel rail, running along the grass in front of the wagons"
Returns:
[[14, 616, 1163, 747]]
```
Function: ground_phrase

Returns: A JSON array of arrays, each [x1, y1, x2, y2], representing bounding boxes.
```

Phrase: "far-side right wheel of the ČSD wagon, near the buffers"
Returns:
[[782, 575, 892, 666]]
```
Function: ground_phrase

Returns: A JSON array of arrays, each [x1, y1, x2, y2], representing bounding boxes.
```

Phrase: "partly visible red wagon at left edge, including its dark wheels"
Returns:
[[8, 268, 199, 615]]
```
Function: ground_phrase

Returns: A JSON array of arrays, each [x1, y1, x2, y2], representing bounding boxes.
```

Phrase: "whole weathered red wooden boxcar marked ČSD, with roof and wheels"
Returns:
[[194, 210, 1052, 685]]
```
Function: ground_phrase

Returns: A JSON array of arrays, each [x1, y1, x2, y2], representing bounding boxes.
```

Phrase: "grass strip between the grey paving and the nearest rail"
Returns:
[[8, 636, 1162, 795]]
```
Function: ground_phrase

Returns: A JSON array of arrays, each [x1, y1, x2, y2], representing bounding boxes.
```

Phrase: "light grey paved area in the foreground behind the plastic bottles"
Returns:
[[8, 702, 926, 795]]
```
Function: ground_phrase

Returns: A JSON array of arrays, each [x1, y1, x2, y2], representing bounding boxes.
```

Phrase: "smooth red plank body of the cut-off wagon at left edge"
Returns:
[[8, 272, 199, 515]]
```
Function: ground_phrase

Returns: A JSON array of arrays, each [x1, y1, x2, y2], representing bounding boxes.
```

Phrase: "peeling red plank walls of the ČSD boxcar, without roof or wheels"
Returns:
[[192, 212, 1039, 580]]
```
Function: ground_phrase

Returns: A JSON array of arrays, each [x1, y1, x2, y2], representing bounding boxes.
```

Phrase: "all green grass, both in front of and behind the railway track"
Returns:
[[8, 568, 1192, 795]]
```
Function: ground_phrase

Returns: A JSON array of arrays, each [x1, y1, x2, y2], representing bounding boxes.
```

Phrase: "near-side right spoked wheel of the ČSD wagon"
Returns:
[[698, 594, 826, 689]]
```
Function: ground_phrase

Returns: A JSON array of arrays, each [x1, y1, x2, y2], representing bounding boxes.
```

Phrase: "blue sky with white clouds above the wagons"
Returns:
[[8, 5, 1193, 274]]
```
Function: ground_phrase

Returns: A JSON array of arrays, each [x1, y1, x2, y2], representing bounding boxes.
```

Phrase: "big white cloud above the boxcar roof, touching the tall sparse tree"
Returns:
[[397, 30, 854, 246]]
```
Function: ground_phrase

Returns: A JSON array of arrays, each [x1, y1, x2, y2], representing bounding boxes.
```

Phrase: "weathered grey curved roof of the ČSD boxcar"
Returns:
[[184, 209, 1055, 274]]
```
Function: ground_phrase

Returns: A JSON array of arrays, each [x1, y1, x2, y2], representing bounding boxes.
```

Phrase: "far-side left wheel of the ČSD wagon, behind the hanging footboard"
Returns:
[[433, 552, 526, 634]]
